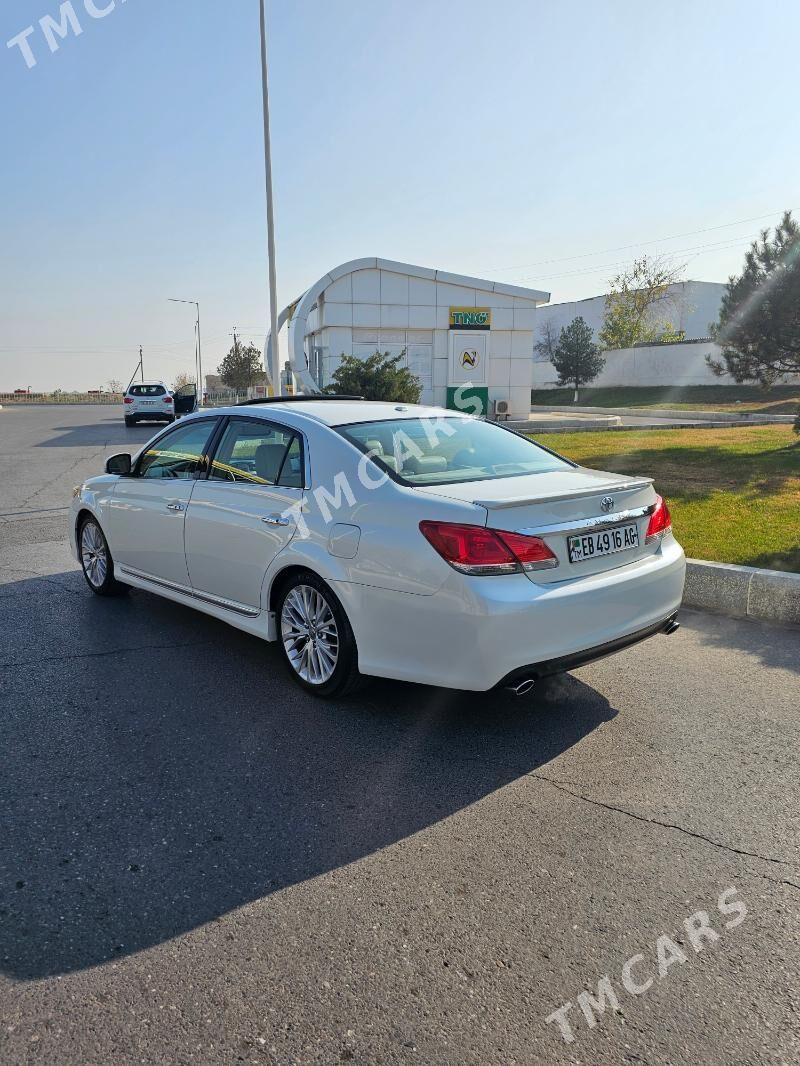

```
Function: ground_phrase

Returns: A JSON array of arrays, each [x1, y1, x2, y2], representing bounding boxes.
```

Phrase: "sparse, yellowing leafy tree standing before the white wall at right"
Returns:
[[597, 256, 684, 350]]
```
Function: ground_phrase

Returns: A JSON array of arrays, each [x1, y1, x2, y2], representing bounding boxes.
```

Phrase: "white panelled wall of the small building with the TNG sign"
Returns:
[[307, 268, 537, 418]]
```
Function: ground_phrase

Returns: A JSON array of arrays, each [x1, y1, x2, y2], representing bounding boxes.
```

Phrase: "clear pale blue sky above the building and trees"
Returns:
[[0, 0, 800, 391]]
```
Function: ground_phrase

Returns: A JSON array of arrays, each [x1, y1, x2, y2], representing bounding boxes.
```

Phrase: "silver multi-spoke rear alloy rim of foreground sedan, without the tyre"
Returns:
[[281, 585, 339, 684]]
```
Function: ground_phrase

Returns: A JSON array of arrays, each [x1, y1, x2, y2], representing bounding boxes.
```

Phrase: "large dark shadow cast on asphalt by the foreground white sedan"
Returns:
[[0, 572, 615, 980]]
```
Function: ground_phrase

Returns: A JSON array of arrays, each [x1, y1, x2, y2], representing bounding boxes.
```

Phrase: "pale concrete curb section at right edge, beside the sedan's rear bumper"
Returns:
[[684, 559, 800, 626]]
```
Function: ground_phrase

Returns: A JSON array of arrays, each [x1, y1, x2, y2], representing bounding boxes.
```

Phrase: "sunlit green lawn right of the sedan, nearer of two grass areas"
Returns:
[[533, 425, 800, 572]]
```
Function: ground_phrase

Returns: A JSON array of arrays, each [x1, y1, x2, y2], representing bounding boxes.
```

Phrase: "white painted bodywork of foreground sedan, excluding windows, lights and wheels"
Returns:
[[69, 398, 685, 691]]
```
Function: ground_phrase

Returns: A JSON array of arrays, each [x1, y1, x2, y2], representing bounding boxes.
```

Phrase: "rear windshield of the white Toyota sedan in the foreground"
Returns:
[[337, 416, 573, 485]]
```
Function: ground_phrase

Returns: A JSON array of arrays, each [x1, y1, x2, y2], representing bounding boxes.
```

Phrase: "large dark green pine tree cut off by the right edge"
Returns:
[[707, 211, 800, 433]]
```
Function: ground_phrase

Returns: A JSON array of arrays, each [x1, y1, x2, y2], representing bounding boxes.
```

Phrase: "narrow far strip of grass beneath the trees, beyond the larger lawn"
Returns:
[[530, 385, 800, 415]]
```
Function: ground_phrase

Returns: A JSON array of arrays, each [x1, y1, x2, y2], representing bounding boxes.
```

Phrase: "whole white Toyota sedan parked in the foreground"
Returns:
[[69, 397, 686, 696]]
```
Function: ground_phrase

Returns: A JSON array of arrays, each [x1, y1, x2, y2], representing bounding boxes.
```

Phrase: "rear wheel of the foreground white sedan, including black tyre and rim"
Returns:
[[276, 571, 361, 697]]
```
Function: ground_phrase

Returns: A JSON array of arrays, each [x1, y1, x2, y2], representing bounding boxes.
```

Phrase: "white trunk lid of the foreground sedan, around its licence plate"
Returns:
[[415, 467, 658, 584]]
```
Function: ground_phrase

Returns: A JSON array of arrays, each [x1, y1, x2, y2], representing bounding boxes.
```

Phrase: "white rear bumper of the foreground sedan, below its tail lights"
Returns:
[[334, 536, 686, 692]]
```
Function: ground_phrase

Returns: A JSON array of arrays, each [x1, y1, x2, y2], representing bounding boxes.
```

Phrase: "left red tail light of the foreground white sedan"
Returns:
[[419, 522, 558, 576]]
